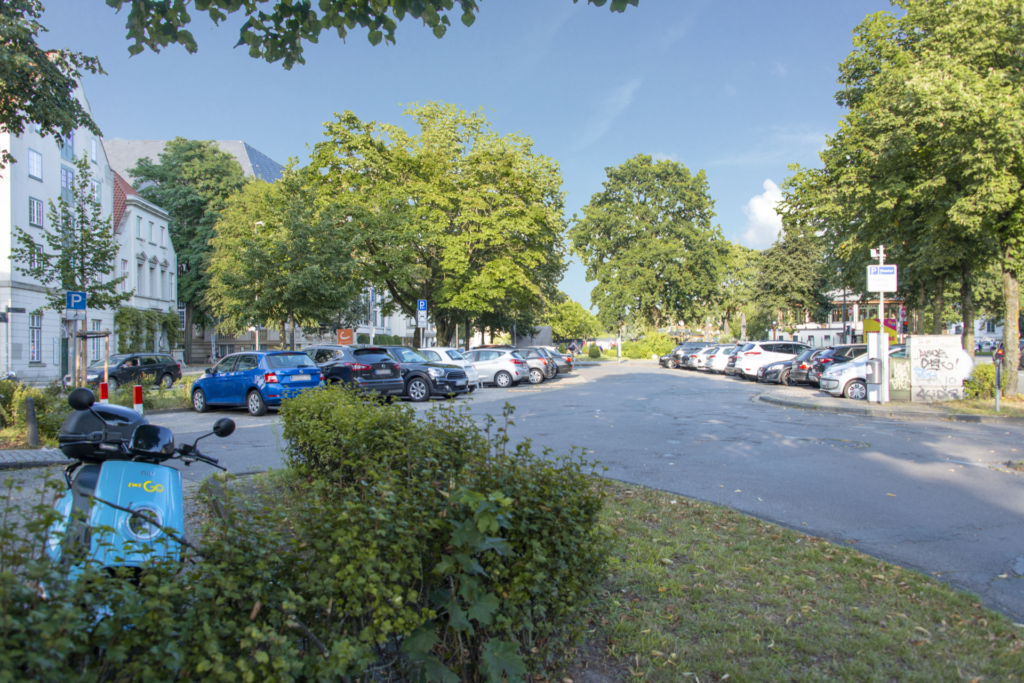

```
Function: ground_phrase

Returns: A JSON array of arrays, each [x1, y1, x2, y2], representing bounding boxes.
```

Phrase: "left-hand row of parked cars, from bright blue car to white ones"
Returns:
[[190, 344, 572, 416]]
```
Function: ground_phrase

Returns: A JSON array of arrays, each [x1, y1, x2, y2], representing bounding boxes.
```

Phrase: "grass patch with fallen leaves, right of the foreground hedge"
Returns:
[[570, 482, 1024, 683]]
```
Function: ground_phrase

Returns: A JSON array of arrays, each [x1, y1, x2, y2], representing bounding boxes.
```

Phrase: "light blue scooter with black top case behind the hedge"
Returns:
[[46, 388, 234, 568]]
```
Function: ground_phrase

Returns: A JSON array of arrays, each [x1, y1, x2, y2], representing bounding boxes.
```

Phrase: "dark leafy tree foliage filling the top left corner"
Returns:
[[0, 0, 104, 170]]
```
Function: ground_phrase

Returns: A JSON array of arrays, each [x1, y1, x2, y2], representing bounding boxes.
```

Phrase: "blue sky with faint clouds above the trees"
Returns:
[[40, 0, 890, 305]]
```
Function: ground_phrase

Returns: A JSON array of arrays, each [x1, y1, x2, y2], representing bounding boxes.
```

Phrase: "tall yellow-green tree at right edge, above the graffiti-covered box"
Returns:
[[806, 0, 1024, 395]]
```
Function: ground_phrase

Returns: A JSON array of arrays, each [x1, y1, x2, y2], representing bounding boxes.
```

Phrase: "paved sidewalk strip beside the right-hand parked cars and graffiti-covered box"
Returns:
[[758, 387, 1024, 425]]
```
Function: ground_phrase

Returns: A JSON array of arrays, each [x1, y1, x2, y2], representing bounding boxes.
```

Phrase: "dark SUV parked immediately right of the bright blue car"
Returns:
[[302, 344, 406, 398]]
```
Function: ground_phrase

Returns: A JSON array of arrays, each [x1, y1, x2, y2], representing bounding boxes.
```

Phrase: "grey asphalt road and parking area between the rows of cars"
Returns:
[[152, 364, 1024, 623]]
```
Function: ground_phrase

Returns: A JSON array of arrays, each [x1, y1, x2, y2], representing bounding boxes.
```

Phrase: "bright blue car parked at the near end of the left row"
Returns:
[[191, 351, 324, 416]]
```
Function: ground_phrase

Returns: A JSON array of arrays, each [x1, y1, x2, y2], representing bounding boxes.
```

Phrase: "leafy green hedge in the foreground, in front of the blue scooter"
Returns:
[[0, 386, 608, 683]]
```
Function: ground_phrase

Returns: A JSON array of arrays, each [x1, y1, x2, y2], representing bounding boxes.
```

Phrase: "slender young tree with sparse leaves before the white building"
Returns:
[[10, 157, 133, 311]]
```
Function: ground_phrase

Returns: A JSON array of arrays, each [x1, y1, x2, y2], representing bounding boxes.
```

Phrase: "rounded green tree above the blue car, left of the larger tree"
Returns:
[[207, 169, 362, 348]]
